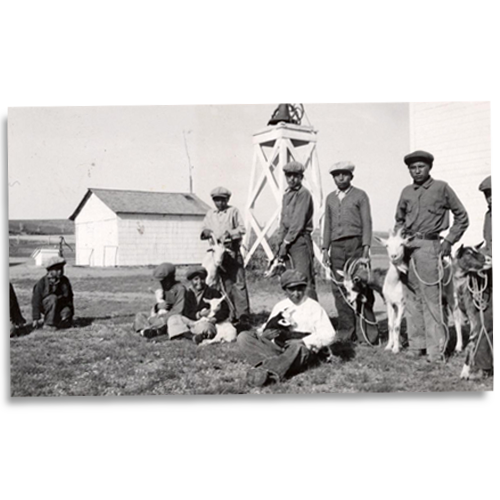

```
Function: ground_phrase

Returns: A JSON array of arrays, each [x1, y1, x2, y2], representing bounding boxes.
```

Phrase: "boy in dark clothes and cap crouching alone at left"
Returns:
[[31, 257, 75, 329]]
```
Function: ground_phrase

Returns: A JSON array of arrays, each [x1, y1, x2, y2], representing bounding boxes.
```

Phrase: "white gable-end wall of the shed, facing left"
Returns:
[[75, 194, 118, 266]]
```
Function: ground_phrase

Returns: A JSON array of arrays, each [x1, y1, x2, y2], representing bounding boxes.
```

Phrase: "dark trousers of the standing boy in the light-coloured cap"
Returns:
[[330, 236, 378, 344]]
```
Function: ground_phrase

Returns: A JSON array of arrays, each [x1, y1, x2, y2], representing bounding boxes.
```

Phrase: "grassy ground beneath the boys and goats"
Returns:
[[9, 236, 494, 397]]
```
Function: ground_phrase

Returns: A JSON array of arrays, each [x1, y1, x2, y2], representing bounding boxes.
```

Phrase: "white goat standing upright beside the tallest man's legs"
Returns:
[[375, 230, 410, 354]]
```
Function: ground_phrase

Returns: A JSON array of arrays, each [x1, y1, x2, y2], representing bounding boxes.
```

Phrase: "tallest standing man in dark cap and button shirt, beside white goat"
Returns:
[[395, 151, 469, 363]]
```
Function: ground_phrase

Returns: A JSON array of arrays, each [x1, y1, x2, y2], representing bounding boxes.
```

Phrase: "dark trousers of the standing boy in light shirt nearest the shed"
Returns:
[[220, 252, 250, 322]]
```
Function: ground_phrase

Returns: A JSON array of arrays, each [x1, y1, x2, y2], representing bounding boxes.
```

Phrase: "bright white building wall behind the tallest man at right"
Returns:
[[410, 101, 492, 244]]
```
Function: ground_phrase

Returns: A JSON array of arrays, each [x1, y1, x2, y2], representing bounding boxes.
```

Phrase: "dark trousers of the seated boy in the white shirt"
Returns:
[[237, 332, 316, 380]]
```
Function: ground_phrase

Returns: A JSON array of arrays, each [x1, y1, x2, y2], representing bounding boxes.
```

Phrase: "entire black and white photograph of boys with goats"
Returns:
[[7, 100, 494, 398]]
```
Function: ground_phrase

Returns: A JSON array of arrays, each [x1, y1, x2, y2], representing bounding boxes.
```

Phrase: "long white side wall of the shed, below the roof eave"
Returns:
[[118, 214, 207, 266]]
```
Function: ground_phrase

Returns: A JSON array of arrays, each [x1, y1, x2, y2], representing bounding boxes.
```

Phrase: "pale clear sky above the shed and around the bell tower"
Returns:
[[8, 100, 410, 231]]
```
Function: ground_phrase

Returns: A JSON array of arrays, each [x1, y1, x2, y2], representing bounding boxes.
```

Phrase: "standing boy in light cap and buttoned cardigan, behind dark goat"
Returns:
[[323, 161, 378, 344]]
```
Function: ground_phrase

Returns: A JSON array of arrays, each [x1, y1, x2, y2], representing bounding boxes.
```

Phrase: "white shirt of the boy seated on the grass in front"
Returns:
[[269, 297, 335, 350]]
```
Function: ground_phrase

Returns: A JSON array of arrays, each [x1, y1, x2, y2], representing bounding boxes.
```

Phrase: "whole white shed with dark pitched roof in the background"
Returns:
[[70, 188, 209, 266]]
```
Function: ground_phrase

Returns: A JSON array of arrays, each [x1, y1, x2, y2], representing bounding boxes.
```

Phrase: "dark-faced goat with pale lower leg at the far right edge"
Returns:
[[452, 245, 493, 379]]
